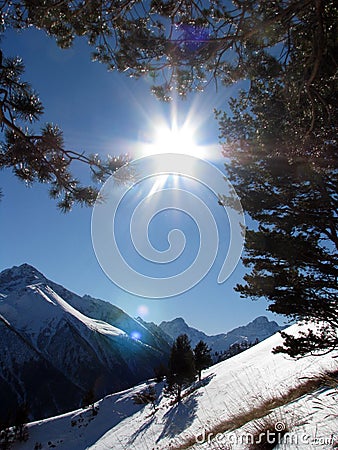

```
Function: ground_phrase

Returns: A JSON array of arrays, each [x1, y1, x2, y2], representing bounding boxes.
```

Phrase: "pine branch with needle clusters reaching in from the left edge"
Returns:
[[0, 46, 128, 212]]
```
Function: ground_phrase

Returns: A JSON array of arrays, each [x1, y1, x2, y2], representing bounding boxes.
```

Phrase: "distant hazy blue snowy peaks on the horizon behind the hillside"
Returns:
[[159, 316, 285, 352]]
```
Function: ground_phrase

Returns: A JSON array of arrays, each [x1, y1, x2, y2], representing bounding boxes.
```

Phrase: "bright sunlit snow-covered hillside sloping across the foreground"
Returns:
[[13, 325, 338, 450]]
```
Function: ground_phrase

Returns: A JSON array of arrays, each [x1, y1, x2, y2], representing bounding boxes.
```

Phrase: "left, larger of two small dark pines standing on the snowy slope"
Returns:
[[167, 334, 196, 402]]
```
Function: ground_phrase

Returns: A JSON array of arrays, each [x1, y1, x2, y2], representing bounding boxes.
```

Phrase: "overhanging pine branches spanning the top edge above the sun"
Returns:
[[2, 0, 335, 99]]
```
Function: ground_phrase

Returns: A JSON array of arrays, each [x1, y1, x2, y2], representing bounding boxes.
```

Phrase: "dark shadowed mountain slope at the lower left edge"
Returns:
[[0, 316, 85, 420]]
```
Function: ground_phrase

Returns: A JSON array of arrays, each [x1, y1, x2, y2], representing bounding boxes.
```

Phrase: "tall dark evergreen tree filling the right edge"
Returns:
[[218, 1, 338, 356]]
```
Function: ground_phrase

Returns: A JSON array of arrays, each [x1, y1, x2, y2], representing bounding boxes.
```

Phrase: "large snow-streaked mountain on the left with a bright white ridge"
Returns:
[[0, 264, 170, 418]]
